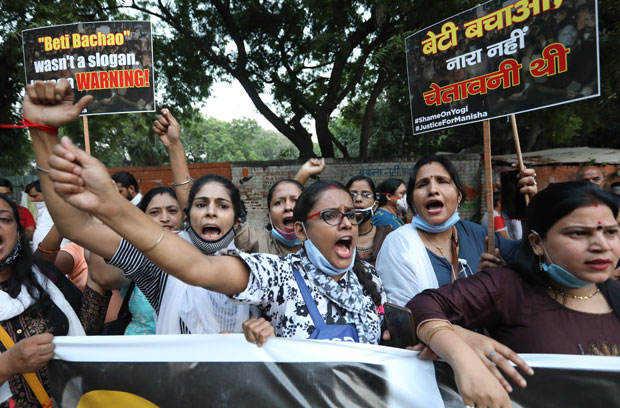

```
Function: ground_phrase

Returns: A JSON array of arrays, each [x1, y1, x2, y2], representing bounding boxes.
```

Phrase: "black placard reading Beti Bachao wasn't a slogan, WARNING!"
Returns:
[[22, 21, 155, 115]]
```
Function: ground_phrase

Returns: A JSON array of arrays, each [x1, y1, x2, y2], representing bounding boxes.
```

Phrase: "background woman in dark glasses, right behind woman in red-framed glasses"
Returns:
[[346, 175, 393, 265]]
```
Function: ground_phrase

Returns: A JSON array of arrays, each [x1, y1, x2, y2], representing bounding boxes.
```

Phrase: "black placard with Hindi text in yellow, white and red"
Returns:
[[406, 0, 600, 133]]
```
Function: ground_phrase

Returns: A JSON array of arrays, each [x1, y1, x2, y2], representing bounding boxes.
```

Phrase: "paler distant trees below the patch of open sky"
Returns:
[[64, 111, 297, 167]]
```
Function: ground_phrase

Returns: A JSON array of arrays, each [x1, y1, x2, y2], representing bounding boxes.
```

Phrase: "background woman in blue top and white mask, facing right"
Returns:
[[372, 178, 408, 230]]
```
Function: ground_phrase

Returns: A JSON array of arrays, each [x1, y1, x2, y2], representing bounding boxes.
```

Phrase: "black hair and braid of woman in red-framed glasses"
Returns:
[[293, 180, 381, 306]]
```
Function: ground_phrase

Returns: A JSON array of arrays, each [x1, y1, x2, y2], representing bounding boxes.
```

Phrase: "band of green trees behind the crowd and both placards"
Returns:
[[0, 0, 620, 173]]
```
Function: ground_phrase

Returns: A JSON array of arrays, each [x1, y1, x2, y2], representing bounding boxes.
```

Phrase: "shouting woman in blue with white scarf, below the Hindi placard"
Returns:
[[376, 156, 536, 306]]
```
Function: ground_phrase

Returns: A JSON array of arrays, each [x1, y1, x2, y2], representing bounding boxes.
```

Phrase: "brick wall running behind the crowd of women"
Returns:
[[92, 158, 620, 225]]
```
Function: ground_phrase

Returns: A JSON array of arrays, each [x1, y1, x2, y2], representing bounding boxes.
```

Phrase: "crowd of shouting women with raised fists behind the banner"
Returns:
[[0, 80, 620, 407]]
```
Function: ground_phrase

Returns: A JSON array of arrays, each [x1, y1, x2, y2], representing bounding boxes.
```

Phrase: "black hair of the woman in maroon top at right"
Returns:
[[509, 181, 618, 286]]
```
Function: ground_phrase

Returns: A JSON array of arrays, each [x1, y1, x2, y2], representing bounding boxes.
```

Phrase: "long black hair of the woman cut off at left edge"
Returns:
[[0, 194, 51, 310]]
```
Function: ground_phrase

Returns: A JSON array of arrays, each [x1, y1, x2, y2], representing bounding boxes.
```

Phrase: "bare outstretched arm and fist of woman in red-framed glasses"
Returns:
[[50, 137, 249, 294]]
